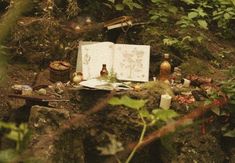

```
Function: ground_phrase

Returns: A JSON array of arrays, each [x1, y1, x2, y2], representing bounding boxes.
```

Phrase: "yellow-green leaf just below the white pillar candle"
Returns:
[[153, 109, 179, 121]]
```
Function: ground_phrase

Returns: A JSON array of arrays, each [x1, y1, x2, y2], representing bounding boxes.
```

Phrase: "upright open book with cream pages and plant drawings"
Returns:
[[76, 42, 150, 82]]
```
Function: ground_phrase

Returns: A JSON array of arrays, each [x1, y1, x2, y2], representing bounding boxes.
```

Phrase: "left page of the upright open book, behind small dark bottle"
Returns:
[[81, 42, 113, 80]]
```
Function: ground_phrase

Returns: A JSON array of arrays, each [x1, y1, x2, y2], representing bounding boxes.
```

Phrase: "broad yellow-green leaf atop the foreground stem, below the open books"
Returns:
[[108, 96, 147, 110]]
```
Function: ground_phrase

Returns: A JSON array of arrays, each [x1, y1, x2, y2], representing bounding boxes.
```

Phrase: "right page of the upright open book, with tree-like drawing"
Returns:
[[113, 44, 150, 82]]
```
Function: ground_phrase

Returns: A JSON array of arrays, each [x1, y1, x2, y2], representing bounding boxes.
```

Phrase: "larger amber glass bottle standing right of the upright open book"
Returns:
[[159, 54, 171, 81]]
